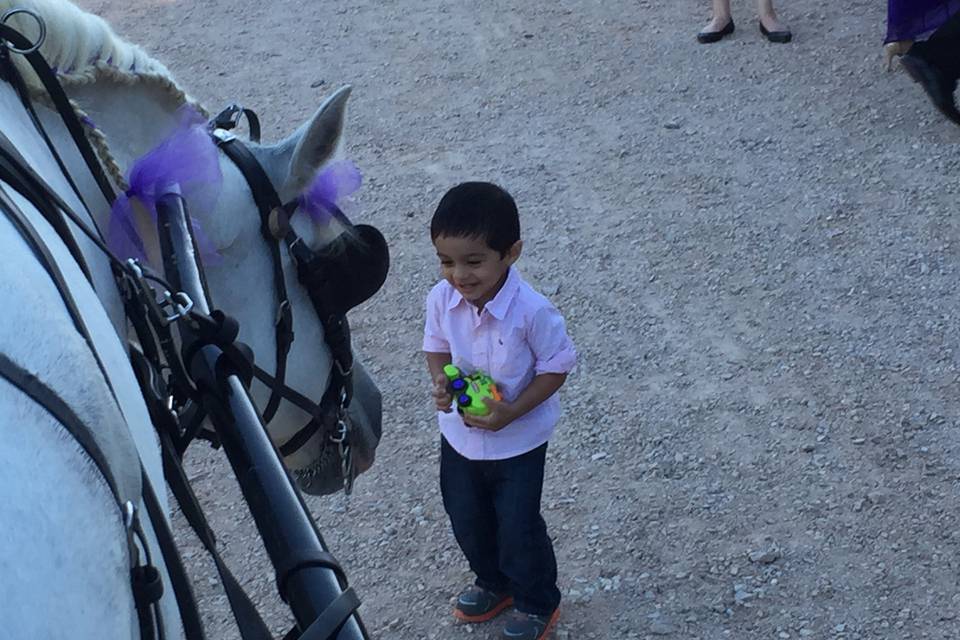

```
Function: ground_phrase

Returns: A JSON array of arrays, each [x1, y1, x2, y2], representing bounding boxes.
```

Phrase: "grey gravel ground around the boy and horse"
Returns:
[[83, 0, 960, 640]]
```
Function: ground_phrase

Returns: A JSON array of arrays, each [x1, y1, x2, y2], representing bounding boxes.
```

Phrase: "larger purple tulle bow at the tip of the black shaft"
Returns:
[[108, 107, 223, 264]]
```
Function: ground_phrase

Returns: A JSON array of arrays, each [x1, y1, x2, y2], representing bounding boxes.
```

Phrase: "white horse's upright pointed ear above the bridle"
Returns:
[[279, 86, 352, 202]]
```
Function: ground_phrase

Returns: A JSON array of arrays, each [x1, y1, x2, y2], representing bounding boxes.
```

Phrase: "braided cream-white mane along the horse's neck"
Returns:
[[0, 0, 209, 189]]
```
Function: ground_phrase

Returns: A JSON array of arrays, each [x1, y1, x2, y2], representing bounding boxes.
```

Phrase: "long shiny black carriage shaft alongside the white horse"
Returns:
[[157, 193, 368, 640]]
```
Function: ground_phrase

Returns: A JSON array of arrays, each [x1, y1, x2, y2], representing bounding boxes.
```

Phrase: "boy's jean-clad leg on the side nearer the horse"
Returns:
[[440, 437, 509, 593]]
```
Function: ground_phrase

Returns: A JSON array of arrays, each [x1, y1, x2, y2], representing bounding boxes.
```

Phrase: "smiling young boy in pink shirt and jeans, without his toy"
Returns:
[[423, 182, 576, 640]]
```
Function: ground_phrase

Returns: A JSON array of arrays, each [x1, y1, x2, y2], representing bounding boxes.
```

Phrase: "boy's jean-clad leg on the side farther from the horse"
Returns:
[[494, 444, 560, 616]]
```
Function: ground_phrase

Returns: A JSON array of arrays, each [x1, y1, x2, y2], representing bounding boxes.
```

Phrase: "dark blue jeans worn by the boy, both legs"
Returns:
[[440, 436, 560, 615]]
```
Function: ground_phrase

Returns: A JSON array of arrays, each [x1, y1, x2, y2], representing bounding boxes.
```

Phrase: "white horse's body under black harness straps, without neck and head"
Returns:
[[0, 77, 181, 640]]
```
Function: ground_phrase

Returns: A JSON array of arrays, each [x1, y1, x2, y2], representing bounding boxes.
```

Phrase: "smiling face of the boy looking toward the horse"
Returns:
[[433, 235, 523, 308]]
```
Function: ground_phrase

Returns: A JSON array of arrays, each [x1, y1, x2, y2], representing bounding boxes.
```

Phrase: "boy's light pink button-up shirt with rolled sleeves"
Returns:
[[423, 268, 577, 460]]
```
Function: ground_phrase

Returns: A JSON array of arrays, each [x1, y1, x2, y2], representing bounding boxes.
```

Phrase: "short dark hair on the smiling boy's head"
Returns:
[[430, 182, 520, 257]]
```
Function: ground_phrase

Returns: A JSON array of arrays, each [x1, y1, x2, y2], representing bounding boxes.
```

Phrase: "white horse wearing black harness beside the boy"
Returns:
[[0, 0, 380, 640]]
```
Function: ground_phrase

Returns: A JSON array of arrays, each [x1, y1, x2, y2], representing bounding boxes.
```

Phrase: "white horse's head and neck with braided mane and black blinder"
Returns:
[[3, 0, 387, 493]]
